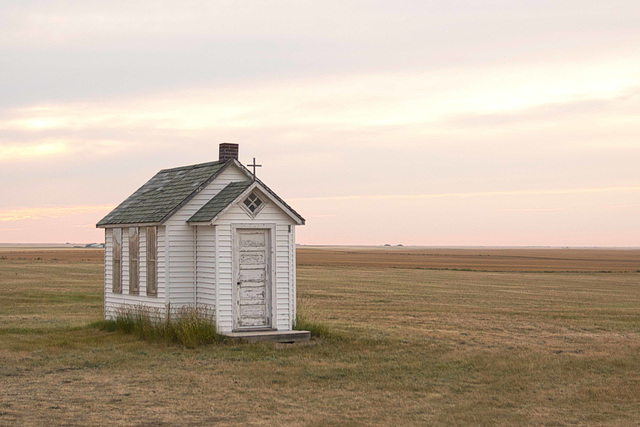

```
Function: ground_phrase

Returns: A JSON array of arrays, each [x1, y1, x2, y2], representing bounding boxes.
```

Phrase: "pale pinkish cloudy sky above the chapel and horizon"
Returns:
[[0, 0, 640, 246]]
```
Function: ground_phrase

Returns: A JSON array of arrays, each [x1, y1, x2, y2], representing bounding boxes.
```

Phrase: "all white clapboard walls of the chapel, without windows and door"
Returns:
[[105, 166, 296, 332]]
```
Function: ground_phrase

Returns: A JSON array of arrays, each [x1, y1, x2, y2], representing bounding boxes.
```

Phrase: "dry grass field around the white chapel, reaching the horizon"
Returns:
[[0, 247, 640, 426]]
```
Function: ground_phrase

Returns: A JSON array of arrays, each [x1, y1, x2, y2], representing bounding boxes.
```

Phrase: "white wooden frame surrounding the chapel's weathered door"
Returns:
[[231, 223, 277, 331]]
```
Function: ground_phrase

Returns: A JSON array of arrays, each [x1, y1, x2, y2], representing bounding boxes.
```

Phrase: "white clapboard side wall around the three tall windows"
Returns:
[[104, 227, 165, 319]]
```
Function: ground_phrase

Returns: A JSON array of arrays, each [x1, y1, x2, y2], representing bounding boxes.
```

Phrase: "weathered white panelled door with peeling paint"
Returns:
[[235, 229, 271, 329]]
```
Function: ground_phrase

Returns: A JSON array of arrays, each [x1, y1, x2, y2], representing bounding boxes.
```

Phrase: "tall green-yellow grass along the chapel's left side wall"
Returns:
[[93, 306, 225, 348]]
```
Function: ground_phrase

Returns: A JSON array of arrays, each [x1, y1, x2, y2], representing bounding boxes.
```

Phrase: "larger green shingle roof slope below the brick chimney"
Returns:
[[97, 161, 226, 227]]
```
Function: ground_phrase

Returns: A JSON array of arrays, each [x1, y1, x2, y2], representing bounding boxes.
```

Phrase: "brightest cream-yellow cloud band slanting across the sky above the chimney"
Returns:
[[0, 59, 640, 132]]
